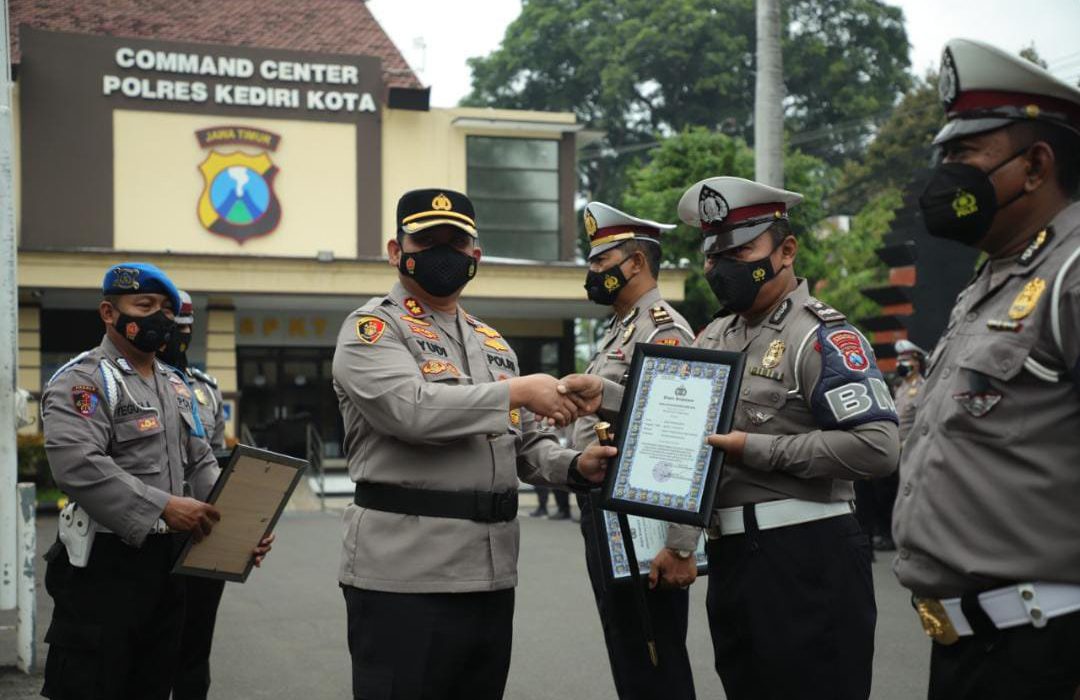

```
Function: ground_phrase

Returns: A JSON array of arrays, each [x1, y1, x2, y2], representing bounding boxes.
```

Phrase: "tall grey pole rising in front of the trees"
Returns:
[[754, 0, 784, 187]]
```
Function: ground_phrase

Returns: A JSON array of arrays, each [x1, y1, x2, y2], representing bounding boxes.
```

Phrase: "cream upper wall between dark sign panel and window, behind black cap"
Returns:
[[382, 107, 575, 250]]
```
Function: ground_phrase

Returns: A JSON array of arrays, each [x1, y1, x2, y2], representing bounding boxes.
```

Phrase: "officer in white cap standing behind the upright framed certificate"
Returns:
[[573, 202, 701, 700]]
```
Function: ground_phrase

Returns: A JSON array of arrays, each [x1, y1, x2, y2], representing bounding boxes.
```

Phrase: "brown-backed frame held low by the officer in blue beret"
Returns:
[[173, 445, 308, 582]]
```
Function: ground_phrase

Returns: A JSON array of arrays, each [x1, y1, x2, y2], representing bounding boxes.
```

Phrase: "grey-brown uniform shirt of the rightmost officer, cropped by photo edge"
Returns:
[[893, 203, 1080, 597]]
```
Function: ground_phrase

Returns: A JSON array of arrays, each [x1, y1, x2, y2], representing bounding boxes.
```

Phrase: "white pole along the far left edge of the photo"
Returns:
[[0, 0, 19, 610]]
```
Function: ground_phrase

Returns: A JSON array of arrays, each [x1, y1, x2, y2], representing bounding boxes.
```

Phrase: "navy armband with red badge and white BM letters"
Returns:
[[810, 324, 900, 430]]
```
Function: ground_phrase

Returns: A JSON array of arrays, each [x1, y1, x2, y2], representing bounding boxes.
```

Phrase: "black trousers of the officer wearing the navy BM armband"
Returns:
[[707, 507, 877, 700]]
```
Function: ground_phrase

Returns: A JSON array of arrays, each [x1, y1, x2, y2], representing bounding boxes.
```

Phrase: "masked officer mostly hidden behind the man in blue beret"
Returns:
[[158, 290, 225, 700]]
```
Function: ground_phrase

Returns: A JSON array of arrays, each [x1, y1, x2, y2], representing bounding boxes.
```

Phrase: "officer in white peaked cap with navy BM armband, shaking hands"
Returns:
[[564, 177, 900, 700]]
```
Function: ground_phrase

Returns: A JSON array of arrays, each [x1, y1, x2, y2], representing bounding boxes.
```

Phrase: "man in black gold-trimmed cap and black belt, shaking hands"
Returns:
[[334, 189, 615, 700]]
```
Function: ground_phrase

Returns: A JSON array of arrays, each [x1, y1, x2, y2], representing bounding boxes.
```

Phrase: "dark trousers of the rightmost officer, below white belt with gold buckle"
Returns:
[[928, 603, 1080, 700]]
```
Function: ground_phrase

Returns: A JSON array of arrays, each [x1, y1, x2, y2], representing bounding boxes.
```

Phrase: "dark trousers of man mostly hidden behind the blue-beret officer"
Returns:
[[173, 576, 225, 700]]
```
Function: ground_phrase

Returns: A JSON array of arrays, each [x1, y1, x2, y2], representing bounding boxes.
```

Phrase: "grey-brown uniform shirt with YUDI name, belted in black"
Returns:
[[334, 284, 578, 593]]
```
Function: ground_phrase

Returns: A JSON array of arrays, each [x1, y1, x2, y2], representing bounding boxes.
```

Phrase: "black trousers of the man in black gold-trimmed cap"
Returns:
[[341, 585, 514, 700]]
